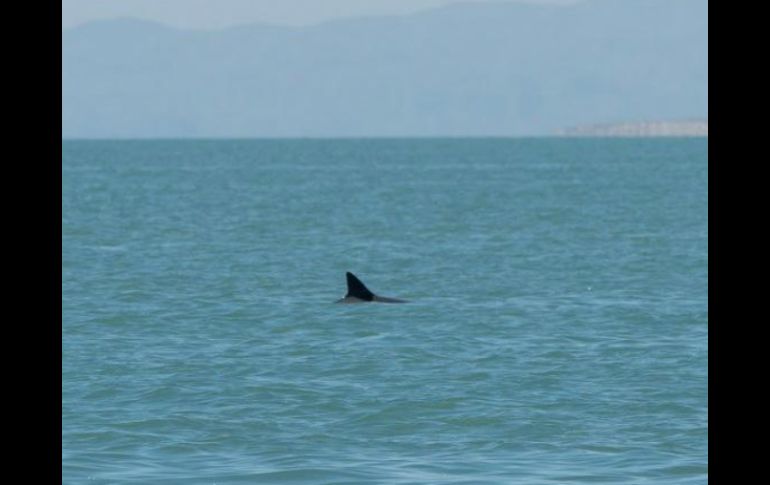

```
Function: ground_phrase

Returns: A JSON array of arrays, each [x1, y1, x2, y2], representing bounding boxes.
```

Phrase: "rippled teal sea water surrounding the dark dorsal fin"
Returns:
[[62, 138, 708, 485]]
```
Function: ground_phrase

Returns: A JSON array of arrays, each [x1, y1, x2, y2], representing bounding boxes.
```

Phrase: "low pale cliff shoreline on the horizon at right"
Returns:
[[557, 119, 709, 137]]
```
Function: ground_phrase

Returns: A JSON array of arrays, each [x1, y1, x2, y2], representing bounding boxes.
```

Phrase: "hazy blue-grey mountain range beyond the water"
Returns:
[[62, 0, 708, 138]]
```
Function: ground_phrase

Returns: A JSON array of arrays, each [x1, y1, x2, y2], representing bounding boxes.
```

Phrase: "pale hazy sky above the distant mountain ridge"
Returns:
[[62, 0, 577, 29]]
